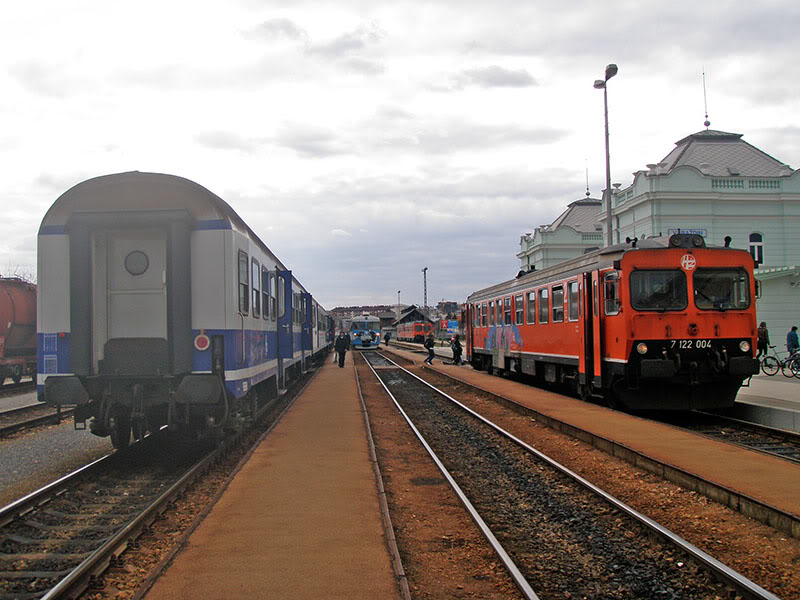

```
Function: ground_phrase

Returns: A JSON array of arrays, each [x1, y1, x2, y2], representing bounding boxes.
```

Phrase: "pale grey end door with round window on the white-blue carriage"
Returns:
[[97, 230, 169, 373]]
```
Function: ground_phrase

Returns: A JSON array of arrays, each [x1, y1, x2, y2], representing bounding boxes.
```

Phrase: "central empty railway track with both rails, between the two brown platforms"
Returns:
[[364, 353, 776, 599]]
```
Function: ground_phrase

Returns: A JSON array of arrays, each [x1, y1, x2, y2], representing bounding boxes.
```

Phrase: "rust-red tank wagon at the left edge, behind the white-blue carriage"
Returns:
[[0, 277, 36, 384]]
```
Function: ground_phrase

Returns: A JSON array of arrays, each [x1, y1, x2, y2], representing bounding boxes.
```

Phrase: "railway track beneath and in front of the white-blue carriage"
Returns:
[[0, 370, 316, 600]]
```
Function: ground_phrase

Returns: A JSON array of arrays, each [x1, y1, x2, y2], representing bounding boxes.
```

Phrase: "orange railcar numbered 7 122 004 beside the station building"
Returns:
[[466, 234, 758, 409]]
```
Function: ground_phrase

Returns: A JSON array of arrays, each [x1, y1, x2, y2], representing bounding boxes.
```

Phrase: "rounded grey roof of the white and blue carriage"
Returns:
[[39, 171, 326, 308]]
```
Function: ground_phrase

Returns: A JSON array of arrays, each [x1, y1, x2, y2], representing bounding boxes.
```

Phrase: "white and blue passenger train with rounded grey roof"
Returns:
[[38, 172, 332, 448]]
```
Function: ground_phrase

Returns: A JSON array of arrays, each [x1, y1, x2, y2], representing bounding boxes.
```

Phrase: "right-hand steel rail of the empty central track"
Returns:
[[373, 357, 780, 600]]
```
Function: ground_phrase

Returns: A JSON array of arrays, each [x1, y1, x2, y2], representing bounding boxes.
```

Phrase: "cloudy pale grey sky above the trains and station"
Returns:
[[0, 0, 800, 308]]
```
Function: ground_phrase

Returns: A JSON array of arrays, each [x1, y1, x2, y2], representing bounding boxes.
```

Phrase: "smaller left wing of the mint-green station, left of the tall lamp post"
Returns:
[[517, 198, 603, 272]]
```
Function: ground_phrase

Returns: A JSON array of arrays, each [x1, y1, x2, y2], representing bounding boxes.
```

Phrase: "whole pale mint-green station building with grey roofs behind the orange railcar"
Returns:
[[517, 130, 800, 338]]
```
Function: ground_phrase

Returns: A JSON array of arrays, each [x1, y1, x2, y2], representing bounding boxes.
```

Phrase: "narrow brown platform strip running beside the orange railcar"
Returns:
[[393, 349, 800, 516]]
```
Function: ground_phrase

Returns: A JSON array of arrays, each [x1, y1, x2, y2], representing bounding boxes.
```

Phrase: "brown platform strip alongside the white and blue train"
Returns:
[[146, 352, 400, 600]]
